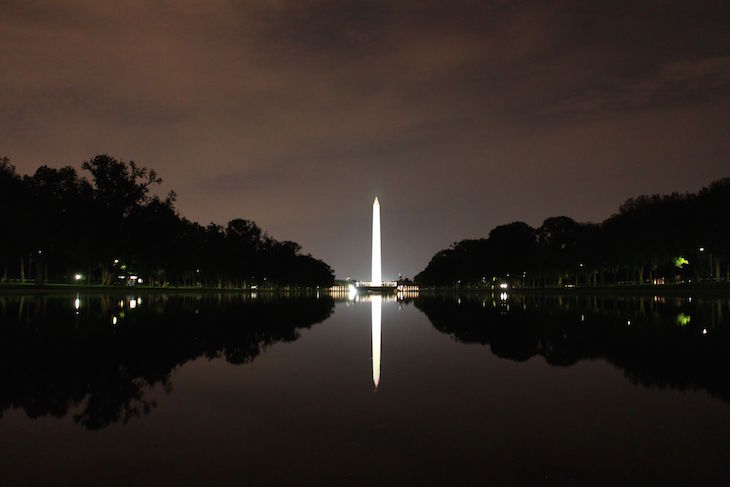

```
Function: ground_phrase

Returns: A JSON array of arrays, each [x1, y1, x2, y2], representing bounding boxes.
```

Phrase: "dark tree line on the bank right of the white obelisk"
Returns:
[[415, 178, 730, 287]]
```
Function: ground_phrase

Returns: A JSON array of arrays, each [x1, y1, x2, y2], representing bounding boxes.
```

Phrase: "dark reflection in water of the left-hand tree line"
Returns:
[[0, 294, 334, 430]]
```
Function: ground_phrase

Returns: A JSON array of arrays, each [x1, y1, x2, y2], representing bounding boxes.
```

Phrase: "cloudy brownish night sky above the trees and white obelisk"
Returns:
[[0, 0, 730, 278]]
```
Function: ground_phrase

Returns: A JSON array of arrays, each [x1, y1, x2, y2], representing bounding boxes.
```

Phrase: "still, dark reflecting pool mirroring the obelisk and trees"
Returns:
[[0, 294, 730, 485]]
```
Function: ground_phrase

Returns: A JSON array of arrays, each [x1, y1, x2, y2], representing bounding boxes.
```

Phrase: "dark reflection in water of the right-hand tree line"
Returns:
[[415, 295, 730, 401]]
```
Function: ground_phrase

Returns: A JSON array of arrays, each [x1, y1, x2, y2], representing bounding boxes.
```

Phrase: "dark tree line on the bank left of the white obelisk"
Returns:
[[0, 154, 334, 288]]
